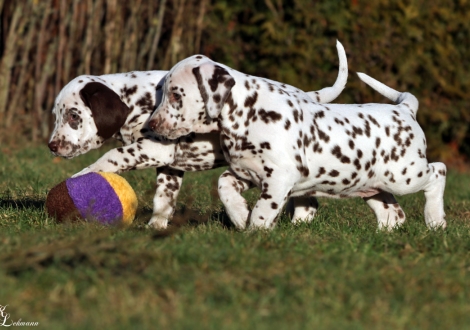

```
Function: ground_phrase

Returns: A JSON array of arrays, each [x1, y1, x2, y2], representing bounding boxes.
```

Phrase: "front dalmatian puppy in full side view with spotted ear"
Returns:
[[149, 45, 446, 229]]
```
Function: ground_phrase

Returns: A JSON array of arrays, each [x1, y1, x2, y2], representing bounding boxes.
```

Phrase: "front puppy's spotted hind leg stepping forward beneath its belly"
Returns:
[[364, 191, 405, 230]]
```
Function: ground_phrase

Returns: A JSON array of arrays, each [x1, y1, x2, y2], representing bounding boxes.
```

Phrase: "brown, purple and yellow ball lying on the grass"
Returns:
[[46, 172, 137, 225]]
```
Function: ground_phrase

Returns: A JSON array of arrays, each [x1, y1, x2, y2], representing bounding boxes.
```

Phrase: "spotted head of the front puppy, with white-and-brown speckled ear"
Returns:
[[149, 55, 235, 139]]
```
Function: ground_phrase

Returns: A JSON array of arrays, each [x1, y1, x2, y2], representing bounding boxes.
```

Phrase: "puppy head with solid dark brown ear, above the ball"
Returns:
[[48, 76, 130, 158]]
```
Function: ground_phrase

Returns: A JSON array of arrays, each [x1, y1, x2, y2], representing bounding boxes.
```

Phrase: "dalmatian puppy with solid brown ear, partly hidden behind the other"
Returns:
[[48, 40, 348, 228]]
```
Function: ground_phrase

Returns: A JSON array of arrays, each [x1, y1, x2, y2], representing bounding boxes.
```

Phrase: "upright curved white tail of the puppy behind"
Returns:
[[307, 41, 348, 103]]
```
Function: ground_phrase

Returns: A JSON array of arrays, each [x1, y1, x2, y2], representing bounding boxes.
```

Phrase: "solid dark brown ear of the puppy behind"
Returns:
[[80, 82, 131, 139]]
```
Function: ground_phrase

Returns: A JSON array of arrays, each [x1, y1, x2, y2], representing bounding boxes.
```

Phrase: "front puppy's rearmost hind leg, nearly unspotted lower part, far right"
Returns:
[[423, 163, 447, 229]]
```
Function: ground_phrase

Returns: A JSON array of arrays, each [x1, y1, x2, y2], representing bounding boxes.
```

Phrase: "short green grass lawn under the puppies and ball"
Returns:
[[0, 146, 470, 329]]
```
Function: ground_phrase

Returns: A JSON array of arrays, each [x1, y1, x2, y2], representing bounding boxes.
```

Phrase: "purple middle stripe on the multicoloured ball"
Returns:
[[66, 173, 122, 224]]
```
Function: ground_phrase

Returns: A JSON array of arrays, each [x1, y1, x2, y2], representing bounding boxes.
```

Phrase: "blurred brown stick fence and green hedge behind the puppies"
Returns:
[[0, 0, 470, 168]]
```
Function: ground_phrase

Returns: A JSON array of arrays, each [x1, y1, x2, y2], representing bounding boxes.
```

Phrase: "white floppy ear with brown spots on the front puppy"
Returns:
[[193, 63, 235, 119]]
